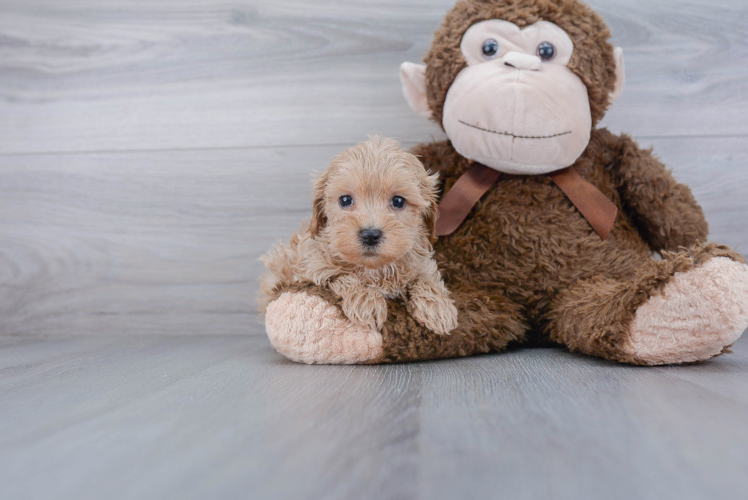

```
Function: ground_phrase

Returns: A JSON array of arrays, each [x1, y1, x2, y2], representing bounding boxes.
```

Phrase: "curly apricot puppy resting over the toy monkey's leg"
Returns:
[[260, 136, 457, 334]]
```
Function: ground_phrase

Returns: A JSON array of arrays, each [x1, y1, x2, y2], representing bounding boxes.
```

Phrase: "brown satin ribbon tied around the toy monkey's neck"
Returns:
[[436, 163, 618, 240]]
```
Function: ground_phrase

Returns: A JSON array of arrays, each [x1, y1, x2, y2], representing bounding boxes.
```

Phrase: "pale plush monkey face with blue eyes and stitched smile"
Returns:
[[442, 20, 592, 174]]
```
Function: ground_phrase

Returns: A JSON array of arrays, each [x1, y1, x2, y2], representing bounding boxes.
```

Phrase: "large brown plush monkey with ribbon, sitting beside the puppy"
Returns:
[[266, 0, 748, 365]]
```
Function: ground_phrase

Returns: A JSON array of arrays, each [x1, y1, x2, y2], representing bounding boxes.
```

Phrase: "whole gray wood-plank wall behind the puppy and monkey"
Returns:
[[0, 0, 748, 335]]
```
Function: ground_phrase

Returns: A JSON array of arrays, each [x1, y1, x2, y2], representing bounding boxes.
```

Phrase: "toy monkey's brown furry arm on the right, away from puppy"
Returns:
[[601, 130, 709, 251]]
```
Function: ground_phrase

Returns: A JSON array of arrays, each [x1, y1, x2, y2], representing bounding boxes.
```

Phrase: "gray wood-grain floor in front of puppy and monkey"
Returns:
[[0, 336, 748, 500]]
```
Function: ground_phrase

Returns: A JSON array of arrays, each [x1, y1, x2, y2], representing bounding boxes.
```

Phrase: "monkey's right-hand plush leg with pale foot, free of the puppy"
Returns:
[[549, 244, 748, 365]]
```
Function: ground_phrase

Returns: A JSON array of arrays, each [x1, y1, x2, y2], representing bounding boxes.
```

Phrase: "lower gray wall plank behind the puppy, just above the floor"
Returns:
[[0, 138, 748, 335]]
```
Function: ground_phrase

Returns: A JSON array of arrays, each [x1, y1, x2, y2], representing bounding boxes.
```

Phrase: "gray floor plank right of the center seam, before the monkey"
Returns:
[[420, 341, 748, 500]]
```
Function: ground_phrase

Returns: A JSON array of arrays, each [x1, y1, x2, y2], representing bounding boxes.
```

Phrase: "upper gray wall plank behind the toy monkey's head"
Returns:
[[0, 0, 748, 153]]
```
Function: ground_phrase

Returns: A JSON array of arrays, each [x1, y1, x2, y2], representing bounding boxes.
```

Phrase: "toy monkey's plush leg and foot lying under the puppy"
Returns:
[[265, 284, 527, 364]]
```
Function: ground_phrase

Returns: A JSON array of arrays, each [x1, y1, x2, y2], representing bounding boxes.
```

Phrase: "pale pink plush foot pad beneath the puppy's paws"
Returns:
[[265, 292, 383, 365]]
